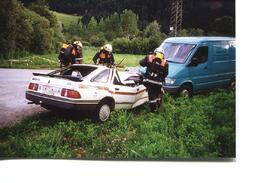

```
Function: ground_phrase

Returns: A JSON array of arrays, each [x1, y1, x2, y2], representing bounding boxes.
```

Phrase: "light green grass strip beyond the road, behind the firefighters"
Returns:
[[0, 47, 144, 69]]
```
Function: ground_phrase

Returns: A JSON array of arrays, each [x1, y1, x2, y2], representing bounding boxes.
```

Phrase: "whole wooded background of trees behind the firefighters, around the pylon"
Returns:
[[0, 0, 235, 57]]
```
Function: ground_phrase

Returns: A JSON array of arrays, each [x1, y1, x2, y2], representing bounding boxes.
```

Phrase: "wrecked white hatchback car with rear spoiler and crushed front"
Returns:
[[26, 64, 148, 121]]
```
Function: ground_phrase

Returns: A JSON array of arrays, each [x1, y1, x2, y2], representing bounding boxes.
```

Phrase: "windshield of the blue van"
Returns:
[[161, 42, 195, 64]]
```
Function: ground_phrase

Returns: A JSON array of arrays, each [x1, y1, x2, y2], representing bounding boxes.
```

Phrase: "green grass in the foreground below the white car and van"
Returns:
[[0, 90, 235, 160]]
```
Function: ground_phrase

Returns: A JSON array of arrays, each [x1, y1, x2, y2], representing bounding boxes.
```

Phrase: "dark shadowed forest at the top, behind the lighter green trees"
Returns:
[[44, 0, 235, 33]]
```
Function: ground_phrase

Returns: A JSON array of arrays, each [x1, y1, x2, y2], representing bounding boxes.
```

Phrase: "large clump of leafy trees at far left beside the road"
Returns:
[[0, 0, 63, 58]]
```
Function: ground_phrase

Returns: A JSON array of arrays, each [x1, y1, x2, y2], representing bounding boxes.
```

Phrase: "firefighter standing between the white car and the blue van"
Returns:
[[140, 48, 168, 112]]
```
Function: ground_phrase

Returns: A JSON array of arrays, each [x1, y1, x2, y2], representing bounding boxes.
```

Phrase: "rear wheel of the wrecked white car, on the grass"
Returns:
[[96, 101, 111, 122]]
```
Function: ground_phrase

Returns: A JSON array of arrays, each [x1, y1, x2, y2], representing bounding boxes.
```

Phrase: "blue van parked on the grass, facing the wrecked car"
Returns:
[[160, 37, 235, 97]]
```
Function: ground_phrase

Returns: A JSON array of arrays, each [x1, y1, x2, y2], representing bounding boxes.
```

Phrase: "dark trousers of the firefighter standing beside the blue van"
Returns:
[[145, 83, 163, 112]]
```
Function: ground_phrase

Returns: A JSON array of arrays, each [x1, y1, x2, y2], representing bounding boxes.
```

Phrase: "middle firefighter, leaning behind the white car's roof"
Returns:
[[93, 44, 114, 67]]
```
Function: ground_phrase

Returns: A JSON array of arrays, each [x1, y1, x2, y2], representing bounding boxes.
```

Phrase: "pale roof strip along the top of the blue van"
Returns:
[[164, 37, 235, 44]]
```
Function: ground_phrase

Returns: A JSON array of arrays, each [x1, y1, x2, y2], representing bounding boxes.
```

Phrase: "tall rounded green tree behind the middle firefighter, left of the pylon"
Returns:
[[120, 10, 139, 39]]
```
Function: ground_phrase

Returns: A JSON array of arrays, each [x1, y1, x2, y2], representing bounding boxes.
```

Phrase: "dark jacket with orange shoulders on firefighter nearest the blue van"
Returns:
[[140, 55, 168, 85]]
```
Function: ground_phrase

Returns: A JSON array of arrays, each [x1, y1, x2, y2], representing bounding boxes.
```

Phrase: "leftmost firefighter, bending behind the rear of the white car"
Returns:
[[58, 41, 83, 68]]
